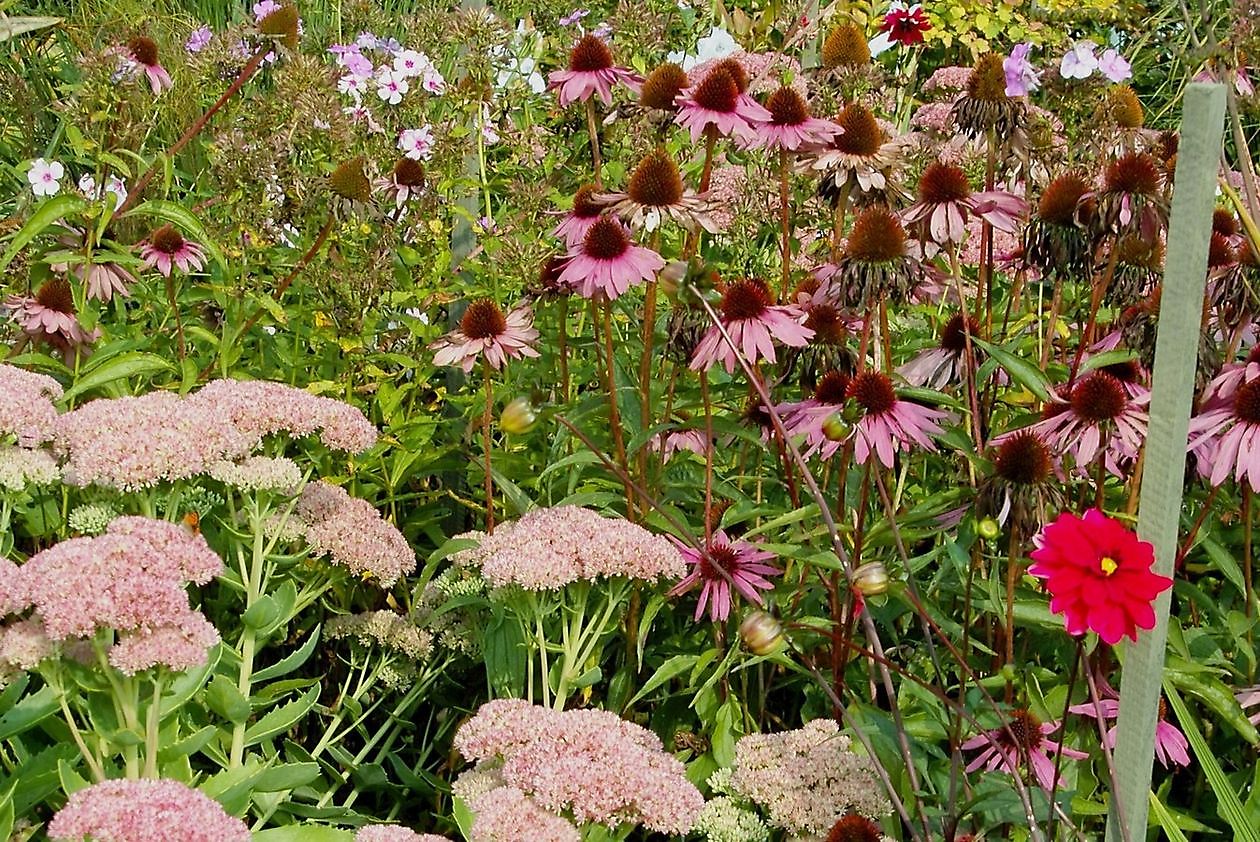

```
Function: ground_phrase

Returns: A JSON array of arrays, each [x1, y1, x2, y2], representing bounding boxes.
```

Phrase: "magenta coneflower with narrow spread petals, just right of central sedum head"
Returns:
[[669, 529, 782, 623]]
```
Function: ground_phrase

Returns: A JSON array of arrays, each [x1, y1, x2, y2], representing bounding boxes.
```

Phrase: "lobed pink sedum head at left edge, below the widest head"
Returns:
[[0, 517, 223, 674]]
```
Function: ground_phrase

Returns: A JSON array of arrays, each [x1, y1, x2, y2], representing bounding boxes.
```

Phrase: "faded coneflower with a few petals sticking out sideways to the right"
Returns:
[[902, 163, 1028, 245]]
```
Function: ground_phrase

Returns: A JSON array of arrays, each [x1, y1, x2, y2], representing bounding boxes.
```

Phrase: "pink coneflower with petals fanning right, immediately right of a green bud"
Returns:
[[848, 372, 949, 468]]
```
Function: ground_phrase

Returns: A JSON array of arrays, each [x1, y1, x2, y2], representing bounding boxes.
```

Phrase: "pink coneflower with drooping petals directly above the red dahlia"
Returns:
[[1023, 372, 1150, 476]]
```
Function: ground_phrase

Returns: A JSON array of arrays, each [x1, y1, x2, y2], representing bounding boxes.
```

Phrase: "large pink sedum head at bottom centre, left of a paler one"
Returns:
[[455, 700, 704, 838]]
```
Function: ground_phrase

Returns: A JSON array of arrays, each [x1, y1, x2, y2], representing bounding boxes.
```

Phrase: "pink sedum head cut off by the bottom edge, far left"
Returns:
[[48, 780, 249, 842]]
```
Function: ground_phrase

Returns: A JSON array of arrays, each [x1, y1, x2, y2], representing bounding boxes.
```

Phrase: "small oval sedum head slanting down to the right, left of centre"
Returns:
[[296, 480, 416, 587]]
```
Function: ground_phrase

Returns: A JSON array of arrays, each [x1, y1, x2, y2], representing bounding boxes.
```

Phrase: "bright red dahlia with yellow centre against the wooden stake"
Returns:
[[1028, 508, 1173, 645]]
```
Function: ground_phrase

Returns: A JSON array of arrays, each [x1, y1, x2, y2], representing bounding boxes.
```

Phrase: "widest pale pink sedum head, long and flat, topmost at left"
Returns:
[[53, 381, 377, 490]]
